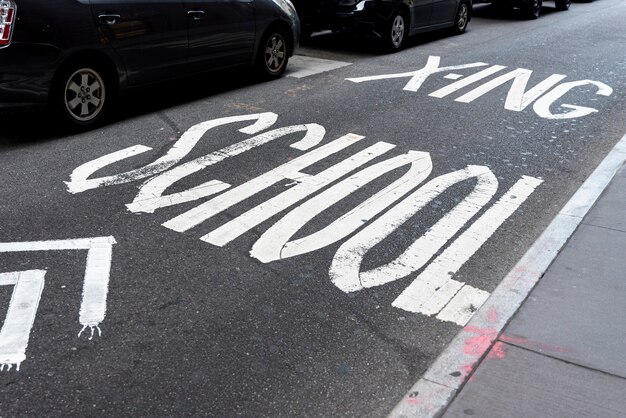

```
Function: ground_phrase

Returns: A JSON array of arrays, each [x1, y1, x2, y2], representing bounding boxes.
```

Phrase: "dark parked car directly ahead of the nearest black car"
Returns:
[[293, 0, 472, 50]]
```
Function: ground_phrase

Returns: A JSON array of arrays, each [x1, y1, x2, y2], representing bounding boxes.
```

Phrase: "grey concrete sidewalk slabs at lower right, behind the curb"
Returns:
[[443, 167, 626, 418]]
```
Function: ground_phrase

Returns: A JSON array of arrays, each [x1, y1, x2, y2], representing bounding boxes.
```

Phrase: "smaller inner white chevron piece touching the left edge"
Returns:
[[0, 270, 46, 371]]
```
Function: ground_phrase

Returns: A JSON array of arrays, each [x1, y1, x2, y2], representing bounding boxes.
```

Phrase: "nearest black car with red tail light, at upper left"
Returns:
[[0, 0, 300, 127]]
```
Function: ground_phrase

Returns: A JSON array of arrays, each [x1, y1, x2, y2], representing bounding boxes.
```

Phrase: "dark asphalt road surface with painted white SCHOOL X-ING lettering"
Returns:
[[0, 0, 626, 417]]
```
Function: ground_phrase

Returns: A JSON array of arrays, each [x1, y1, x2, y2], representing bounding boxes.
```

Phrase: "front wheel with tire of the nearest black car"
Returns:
[[256, 27, 290, 80]]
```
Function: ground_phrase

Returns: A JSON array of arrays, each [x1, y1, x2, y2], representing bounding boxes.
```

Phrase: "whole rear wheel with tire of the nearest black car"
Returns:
[[51, 62, 115, 130]]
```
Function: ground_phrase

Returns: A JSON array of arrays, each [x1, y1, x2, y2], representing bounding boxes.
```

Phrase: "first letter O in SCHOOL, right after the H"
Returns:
[[250, 151, 432, 263]]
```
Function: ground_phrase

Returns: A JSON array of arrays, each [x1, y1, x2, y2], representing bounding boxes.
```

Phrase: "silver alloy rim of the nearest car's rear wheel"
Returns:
[[64, 68, 105, 122]]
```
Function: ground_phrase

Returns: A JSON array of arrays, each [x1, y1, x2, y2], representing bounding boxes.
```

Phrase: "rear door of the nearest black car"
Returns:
[[91, 0, 187, 85]]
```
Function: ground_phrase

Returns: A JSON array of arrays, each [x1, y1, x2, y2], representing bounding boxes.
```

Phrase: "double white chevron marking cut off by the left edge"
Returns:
[[0, 237, 115, 369]]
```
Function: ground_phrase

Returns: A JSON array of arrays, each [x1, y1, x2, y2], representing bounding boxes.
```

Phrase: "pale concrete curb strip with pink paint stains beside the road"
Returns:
[[389, 135, 626, 417]]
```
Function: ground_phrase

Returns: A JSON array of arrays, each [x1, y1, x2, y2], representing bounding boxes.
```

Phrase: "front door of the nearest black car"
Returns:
[[183, 0, 255, 73]]
